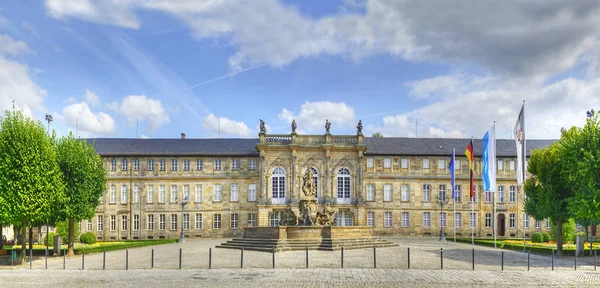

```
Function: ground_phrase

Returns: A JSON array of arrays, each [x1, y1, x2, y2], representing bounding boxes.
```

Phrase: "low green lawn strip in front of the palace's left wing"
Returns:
[[4, 239, 178, 255]]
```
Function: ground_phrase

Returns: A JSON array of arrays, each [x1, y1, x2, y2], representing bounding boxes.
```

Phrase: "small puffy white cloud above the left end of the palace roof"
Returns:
[[109, 95, 170, 131]]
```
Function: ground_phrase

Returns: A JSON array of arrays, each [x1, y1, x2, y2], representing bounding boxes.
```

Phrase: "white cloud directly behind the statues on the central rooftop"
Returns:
[[278, 101, 356, 133]]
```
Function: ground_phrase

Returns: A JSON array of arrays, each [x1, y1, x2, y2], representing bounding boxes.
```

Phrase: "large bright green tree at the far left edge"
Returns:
[[0, 108, 64, 257]]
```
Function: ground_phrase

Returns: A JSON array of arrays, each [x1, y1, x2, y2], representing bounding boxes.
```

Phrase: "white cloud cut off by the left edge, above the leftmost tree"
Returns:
[[0, 35, 47, 117]]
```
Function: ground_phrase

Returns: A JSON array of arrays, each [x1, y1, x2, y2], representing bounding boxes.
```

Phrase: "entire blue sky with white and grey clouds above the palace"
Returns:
[[0, 0, 600, 138]]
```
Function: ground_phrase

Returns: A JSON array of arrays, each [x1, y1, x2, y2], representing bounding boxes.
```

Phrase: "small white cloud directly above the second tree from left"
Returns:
[[62, 102, 117, 135]]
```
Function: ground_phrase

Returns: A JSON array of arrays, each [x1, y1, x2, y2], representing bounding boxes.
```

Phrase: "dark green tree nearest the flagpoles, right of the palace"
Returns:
[[524, 143, 573, 255]]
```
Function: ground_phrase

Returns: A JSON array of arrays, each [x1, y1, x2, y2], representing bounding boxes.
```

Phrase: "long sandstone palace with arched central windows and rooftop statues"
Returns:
[[80, 132, 552, 240]]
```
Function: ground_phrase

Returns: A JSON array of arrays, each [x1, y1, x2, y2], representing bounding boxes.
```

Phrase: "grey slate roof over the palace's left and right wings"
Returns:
[[86, 137, 556, 157]]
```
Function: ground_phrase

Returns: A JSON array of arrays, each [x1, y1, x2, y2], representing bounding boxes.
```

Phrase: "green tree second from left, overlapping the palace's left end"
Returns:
[[58, 133, 106, 257]]
